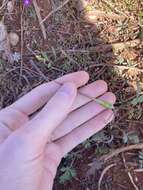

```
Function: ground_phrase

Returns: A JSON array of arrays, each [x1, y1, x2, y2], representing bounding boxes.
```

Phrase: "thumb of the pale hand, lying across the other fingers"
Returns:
[[20, 83, 77, 145]]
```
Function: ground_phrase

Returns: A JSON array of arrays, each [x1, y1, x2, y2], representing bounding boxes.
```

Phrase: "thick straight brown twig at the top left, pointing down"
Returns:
[[33, 0, 47, 40]]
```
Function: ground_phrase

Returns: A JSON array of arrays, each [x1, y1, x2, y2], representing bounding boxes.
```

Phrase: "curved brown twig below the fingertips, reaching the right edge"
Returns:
[[100, 143, 143, 162]]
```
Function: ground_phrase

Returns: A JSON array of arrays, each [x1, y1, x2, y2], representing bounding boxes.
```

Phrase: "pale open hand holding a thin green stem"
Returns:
[[0, 71, 116, 190]]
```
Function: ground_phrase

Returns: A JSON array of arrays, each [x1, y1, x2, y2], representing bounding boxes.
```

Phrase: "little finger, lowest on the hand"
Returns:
[[55, 110, 114, 156]]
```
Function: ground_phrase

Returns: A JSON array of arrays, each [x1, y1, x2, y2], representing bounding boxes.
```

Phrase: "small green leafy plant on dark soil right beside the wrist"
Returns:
[[59, 166, 76, 184]]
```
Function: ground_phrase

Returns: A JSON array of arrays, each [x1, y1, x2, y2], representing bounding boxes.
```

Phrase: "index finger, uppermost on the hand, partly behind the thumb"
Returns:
[[10, 71, 89, 115]]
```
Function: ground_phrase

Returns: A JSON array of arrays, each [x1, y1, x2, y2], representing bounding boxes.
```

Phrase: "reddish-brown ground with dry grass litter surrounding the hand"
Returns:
[[0, 0, 143, 190]]
